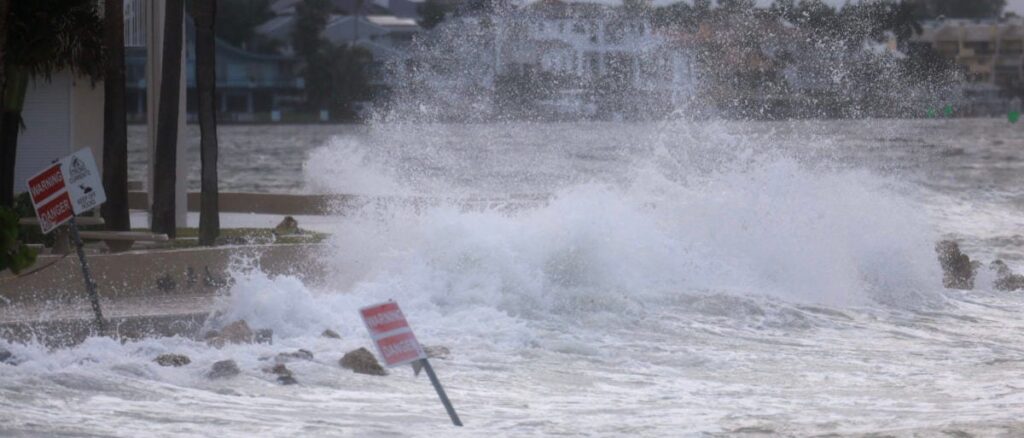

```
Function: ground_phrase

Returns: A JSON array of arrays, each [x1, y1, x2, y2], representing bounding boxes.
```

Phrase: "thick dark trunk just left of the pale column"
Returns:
[[101, 0, 131, 231]]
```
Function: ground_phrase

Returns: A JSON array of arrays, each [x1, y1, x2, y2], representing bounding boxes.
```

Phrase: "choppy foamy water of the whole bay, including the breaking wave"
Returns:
[[6, 120, 1024, 436]]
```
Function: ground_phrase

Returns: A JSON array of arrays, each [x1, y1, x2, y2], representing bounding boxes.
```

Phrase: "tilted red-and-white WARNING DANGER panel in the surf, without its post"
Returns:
[[359, 301, 427, 366]]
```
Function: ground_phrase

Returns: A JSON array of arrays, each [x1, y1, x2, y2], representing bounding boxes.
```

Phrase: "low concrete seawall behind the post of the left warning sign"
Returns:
[[0, 245, 325, 347]]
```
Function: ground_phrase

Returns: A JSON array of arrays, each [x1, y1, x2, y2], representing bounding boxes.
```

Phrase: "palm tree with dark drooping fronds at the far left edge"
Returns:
[[0, 0, 104, 206]]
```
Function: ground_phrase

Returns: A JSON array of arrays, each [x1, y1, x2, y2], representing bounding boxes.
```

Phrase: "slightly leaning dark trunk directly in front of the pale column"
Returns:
[[150, 0, 184, 237]]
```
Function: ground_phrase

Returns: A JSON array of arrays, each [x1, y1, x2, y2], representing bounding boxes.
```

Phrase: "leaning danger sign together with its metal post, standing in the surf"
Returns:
[[359, 301, 462, 427]]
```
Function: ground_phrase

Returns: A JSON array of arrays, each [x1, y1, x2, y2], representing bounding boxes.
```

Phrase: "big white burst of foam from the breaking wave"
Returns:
[[317, 145, 941, 315]]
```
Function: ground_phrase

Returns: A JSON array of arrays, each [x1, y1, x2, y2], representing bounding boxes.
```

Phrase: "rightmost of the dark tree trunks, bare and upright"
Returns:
[[193, 0, 220, 246]]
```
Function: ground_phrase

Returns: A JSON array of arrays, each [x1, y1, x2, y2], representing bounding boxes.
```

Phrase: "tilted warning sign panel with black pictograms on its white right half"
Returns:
[[29, 148, 106, 233]]
